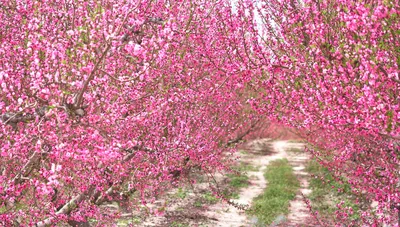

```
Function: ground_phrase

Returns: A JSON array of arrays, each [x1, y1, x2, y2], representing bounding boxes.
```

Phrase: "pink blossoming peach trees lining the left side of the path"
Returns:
[[0, 0, 257, 226]]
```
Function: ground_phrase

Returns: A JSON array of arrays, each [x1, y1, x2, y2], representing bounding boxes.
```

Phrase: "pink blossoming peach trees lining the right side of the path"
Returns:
[[239, 0, 400, 225]]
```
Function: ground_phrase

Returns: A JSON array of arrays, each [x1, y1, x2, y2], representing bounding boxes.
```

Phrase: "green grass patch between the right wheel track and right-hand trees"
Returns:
[[306, 160, 360, 220]]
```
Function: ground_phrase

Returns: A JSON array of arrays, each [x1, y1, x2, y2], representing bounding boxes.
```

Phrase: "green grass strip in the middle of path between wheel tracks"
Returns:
[[248, 159, 300, 225]]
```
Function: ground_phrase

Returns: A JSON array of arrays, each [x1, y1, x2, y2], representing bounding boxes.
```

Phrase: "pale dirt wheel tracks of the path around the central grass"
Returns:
[[204, 139, 311, 227]]
